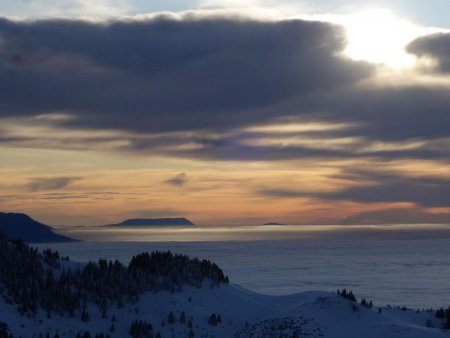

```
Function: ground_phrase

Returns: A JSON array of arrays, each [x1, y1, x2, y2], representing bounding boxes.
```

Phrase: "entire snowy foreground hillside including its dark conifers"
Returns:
[[0, 236, 450, 338]]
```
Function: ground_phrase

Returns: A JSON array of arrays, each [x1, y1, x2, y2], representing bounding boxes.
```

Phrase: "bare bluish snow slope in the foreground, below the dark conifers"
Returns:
[[0, 282, 450, 338]]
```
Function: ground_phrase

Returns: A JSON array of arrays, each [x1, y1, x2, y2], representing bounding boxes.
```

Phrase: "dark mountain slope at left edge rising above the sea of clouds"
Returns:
[[0, 212, 76, 243]]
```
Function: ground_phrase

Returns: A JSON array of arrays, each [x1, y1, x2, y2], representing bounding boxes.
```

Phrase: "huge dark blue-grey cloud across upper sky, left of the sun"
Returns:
[[0, 17, 370, 132]]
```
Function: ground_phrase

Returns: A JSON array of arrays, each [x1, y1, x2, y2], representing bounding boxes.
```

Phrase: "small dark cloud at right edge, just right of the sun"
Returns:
[[406, 33, 450, 73]]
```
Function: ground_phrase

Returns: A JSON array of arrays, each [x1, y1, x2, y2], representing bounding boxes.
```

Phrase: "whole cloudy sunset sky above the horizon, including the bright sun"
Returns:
[[0, 0, 450, 226]]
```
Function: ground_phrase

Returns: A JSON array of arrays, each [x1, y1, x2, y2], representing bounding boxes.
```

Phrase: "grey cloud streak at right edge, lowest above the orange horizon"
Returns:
[[258, 171, 450, 207]]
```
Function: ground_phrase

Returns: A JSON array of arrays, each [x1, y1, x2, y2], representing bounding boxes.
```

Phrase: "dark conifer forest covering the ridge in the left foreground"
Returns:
[[0, 234, 228, 320]]
